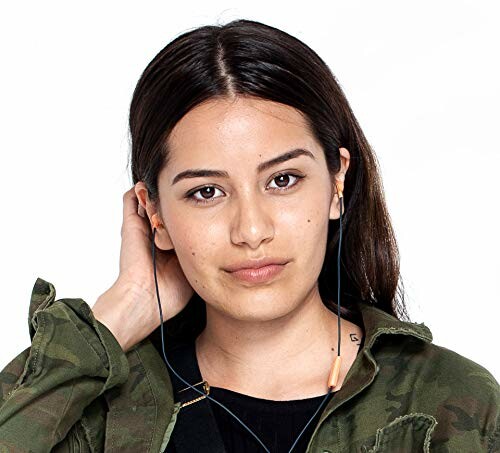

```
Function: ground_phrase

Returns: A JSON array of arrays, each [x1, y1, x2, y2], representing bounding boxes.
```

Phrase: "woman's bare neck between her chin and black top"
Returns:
[[196, 292, 361, 400]]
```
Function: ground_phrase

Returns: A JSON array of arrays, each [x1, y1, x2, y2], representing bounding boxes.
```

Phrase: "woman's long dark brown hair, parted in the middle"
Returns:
[[129, 19, 409, 340]]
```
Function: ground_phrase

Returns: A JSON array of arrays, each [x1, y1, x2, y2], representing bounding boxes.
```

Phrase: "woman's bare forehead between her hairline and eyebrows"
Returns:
[[168, 97, 313, 165]]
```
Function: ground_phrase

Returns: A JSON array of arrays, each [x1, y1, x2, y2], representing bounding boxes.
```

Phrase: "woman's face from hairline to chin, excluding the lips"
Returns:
[[159, 97, 344, 321]]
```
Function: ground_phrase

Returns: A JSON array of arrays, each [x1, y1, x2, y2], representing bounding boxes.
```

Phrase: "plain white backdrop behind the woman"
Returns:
[[0, 0, 500, 379]]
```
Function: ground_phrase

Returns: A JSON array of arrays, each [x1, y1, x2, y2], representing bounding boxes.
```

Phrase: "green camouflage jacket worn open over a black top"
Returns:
[[0, 278, 500, 453]]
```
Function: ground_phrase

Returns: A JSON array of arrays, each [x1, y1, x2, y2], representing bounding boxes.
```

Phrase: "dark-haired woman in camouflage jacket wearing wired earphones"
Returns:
[[0, 20, 500, 453]]
